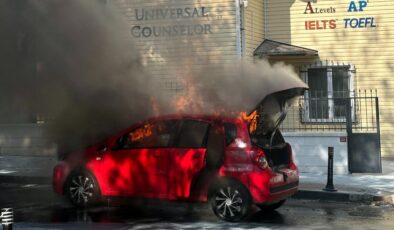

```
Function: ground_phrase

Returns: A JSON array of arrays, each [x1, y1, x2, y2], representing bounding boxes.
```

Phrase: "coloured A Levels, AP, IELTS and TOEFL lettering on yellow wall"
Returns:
[[304, 1, 376, 30]]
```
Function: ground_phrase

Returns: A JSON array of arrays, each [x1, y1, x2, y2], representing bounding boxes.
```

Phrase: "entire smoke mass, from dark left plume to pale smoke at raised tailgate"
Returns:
[[1, 0, 303, 156]]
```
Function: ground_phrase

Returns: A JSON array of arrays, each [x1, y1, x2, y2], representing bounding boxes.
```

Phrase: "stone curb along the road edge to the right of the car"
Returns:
[[292, 190, 394, 204]]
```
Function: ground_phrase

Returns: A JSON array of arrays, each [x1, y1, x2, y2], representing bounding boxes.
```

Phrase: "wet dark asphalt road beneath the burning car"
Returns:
[[0, 183, 394, 230]]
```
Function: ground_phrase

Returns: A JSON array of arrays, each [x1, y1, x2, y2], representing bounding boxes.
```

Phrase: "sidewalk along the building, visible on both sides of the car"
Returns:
[[0, 156, 394, 204]]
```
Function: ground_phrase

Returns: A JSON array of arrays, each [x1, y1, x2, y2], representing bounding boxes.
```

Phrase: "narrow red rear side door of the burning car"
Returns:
[[168, 119, 210, 199]]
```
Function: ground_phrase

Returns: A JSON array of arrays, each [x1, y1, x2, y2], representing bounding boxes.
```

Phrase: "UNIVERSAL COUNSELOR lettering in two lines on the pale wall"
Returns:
[[131, 7, 212, 38]]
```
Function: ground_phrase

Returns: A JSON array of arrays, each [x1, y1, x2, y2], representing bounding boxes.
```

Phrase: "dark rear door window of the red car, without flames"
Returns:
[[177, 120, 209, 148]]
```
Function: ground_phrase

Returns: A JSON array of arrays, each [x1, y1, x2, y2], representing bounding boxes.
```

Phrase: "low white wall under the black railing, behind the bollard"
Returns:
[[283, 132, 348, 174]]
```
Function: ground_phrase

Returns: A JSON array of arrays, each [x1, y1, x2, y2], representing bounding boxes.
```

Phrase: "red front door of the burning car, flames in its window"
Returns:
[[100, 120, 177, 197]]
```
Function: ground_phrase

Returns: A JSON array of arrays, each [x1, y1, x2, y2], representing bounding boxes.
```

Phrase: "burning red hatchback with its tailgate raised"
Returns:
[[53, 88, 304, 221]]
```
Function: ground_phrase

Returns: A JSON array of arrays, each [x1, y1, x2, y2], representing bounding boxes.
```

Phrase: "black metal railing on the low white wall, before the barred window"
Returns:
[[281, 90, 379, 132]]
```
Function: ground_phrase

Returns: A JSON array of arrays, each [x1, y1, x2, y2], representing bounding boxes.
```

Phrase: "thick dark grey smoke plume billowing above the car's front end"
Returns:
[[1, 0, 155, 155]]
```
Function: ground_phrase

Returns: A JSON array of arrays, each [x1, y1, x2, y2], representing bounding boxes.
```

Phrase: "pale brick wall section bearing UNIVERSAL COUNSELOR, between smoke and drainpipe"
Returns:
[[118, 0, 238, 82]]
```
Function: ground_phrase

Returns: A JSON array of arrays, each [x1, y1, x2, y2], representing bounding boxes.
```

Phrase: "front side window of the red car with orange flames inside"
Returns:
[[119, 120, 177, 149]]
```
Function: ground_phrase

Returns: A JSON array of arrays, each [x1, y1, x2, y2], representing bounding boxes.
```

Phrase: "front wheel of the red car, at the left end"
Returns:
[[65, 171, 100, 208]]
